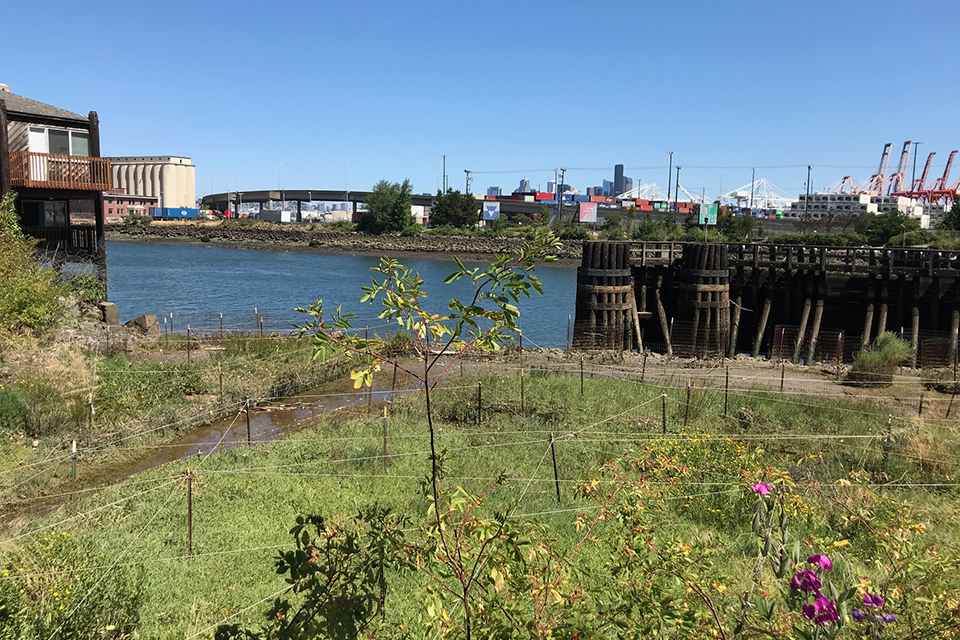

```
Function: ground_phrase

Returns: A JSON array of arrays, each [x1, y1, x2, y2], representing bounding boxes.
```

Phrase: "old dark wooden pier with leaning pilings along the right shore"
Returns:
[[572, 242, 960, 367]]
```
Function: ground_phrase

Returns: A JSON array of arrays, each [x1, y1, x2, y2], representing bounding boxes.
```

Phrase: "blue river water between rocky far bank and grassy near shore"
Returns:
[[107, 242, 577, 348]]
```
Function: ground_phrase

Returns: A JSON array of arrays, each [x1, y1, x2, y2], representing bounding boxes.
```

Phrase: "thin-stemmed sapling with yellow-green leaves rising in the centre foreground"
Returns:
[[298, 229, 560, 640]]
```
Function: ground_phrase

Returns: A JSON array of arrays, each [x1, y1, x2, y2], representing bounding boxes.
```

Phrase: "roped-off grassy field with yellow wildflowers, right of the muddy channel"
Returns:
[[0, 364, 960, 638]]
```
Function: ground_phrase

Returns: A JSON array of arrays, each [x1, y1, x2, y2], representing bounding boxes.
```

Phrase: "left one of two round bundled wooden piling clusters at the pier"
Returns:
[[573, 242, 643, 351]]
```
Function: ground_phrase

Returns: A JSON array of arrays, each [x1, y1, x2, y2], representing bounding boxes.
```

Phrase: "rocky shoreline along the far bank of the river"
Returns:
[[106, 223, 582, 261]]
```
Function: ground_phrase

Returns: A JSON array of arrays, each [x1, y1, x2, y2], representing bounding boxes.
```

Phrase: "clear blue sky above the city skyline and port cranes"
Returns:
[[0, 0, 960, 200]]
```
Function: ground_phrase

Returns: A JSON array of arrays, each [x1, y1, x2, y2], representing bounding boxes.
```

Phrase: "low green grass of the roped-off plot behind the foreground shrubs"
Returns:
[[0, 368, 958, 638]]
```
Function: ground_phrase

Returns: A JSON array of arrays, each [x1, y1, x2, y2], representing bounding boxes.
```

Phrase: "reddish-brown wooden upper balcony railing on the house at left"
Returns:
[[10, 151, 110, 191]]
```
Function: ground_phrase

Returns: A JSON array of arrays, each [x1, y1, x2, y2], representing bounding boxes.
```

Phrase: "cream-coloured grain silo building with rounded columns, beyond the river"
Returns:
[[110, 156, 197, 209]]
